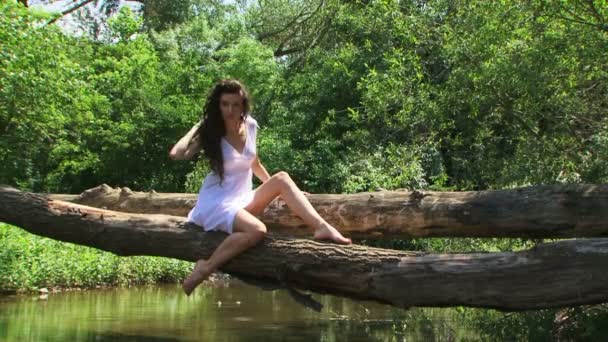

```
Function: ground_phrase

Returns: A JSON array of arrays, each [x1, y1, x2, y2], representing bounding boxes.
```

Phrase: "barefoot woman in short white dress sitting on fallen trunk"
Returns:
[[170, 80, 351, 295]]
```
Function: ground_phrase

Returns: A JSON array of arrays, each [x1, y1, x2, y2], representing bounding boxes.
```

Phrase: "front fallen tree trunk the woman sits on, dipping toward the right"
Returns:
[[0, 188, 608, 310]]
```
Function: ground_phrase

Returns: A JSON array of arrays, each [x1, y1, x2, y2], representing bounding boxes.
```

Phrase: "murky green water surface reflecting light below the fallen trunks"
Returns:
[[0, 280, 580, 342]]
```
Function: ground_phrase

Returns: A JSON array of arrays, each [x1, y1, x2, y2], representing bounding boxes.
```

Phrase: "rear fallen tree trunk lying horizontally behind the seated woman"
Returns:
[[49, 184, 608, 239]]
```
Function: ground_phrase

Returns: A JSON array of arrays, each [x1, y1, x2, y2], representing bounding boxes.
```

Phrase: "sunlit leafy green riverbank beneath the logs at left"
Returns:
[[0, 223, 192, 293]]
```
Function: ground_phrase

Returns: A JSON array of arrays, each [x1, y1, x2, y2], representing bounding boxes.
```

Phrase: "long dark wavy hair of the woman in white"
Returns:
[[195, 79, 250, 184]]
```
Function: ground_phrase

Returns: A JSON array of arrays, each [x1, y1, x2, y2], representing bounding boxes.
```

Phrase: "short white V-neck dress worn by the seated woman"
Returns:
[[188, 115, 259, 234]]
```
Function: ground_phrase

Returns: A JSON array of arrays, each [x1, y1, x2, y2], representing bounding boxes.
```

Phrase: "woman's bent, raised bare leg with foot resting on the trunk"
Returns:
[[240, 171, 351, 244]]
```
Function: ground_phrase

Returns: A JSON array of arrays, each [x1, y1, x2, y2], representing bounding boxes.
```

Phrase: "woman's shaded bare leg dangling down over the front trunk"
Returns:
[[182, 209, 266, 295]]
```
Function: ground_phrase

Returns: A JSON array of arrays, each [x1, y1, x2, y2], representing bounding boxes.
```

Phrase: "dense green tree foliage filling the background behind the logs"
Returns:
[[0, 0, 608, 192]]
